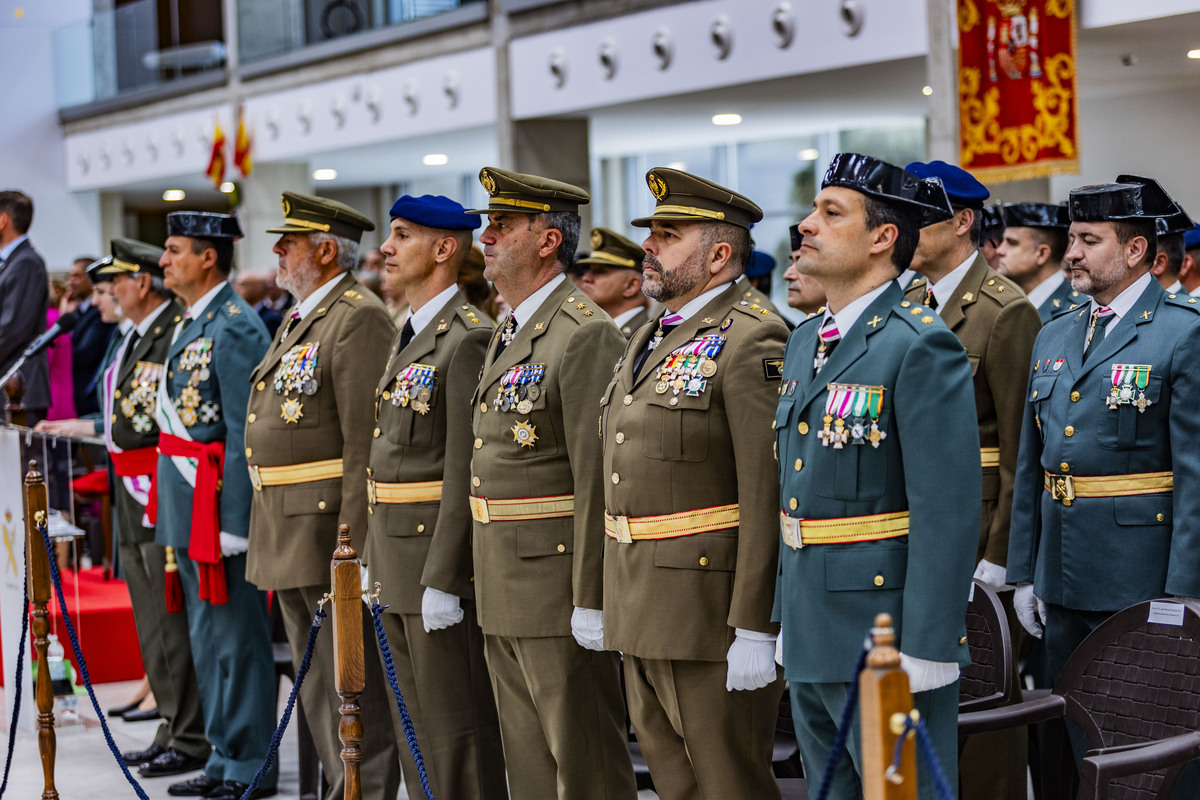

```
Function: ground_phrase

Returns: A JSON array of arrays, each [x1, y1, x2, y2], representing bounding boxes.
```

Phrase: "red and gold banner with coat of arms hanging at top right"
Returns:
[[956, 0, 1079, 181]]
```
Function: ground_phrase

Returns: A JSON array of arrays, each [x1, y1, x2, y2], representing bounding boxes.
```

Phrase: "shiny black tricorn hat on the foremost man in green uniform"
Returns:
[[821, 152, 954, 228]]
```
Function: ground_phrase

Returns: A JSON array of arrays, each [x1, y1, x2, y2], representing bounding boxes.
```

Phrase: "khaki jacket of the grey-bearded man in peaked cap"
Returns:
[[246, 275, 396, 589]]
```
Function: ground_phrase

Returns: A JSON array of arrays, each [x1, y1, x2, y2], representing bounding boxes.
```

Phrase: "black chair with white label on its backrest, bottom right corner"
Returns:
[[959, 600, 1200, 800]]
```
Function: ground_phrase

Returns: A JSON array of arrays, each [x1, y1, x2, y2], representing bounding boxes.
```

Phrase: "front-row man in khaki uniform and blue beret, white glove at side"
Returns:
[[366, 194, 508, 800]]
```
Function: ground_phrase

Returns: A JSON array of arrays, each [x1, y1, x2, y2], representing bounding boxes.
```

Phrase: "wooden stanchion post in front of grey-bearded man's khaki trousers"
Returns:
[[329, 523, 366, 800]]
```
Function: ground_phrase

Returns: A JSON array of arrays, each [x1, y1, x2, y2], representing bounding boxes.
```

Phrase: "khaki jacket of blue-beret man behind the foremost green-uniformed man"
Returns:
[[906, 253, 1042, 566]]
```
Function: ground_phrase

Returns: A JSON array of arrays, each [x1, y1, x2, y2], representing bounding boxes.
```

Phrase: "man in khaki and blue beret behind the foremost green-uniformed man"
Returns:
[[906, 161, 1042, 800]]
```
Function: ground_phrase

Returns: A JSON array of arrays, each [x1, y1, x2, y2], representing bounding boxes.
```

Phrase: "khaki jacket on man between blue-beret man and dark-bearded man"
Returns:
[[470, 281, 625, 637]]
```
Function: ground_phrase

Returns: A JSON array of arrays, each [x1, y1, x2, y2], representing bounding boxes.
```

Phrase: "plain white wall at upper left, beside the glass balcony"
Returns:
[[0, 0, 101, 271]]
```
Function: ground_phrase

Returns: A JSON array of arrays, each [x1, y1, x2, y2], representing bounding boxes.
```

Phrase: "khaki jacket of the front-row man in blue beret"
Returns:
[[366, 291, 494, 614]]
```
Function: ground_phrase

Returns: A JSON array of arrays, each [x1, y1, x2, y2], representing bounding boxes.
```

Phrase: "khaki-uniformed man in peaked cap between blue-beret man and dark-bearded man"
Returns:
[[470, 167, 635, 800]]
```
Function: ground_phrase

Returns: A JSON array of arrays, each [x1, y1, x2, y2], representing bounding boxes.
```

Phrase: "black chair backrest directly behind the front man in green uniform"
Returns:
[[959, 581, 1014, 711]]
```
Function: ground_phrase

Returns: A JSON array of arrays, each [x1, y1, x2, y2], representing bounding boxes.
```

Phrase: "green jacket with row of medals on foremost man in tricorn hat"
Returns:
[[775, 281, 982, 682]]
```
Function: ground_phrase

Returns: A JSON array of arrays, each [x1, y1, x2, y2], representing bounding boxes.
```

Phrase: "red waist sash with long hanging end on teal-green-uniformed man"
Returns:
[[158, 432, 229, 606]]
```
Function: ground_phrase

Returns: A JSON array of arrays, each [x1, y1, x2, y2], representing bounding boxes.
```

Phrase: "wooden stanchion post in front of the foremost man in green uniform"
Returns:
[[858, 614, 917, 800]]
